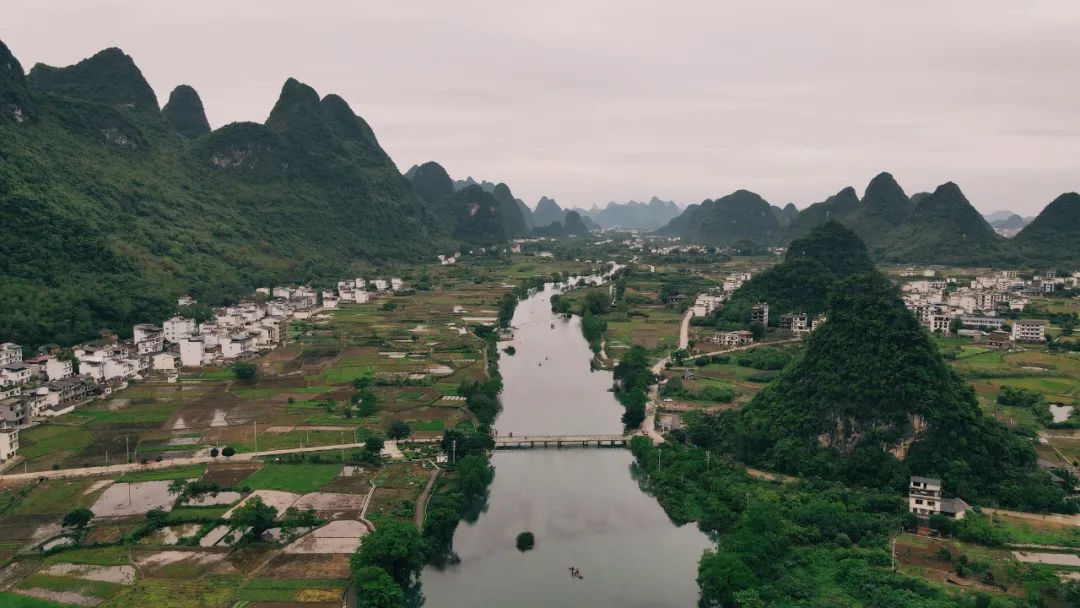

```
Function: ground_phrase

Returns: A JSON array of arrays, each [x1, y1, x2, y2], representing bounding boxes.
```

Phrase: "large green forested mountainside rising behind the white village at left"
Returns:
[[0, 43, 454, 347]]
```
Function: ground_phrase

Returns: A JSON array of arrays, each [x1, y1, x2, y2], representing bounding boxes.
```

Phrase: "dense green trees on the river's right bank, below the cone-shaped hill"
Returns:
[[631, 437, 1071, 608]]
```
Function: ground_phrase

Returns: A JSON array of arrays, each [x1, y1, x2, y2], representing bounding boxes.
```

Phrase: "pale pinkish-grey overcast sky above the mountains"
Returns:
[[0, 0, 1080, 215]]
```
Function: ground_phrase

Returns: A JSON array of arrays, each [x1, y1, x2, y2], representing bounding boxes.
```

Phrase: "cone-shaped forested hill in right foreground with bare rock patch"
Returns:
[[691, 270, 1065, 511]]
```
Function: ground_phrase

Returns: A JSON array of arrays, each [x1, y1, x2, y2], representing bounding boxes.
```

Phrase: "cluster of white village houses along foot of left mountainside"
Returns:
[[0, 278, 419, 467]]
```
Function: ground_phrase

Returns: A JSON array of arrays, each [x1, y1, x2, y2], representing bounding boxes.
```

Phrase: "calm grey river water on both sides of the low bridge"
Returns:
[[421, 286, 712, 608]]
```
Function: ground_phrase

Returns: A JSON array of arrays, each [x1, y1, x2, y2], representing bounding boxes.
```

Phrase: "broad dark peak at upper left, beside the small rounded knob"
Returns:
[[27, 48, 158, 112]]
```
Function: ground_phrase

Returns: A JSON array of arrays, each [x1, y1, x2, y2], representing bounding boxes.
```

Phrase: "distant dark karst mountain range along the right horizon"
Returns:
[[657, 173, 1080, 265]]
